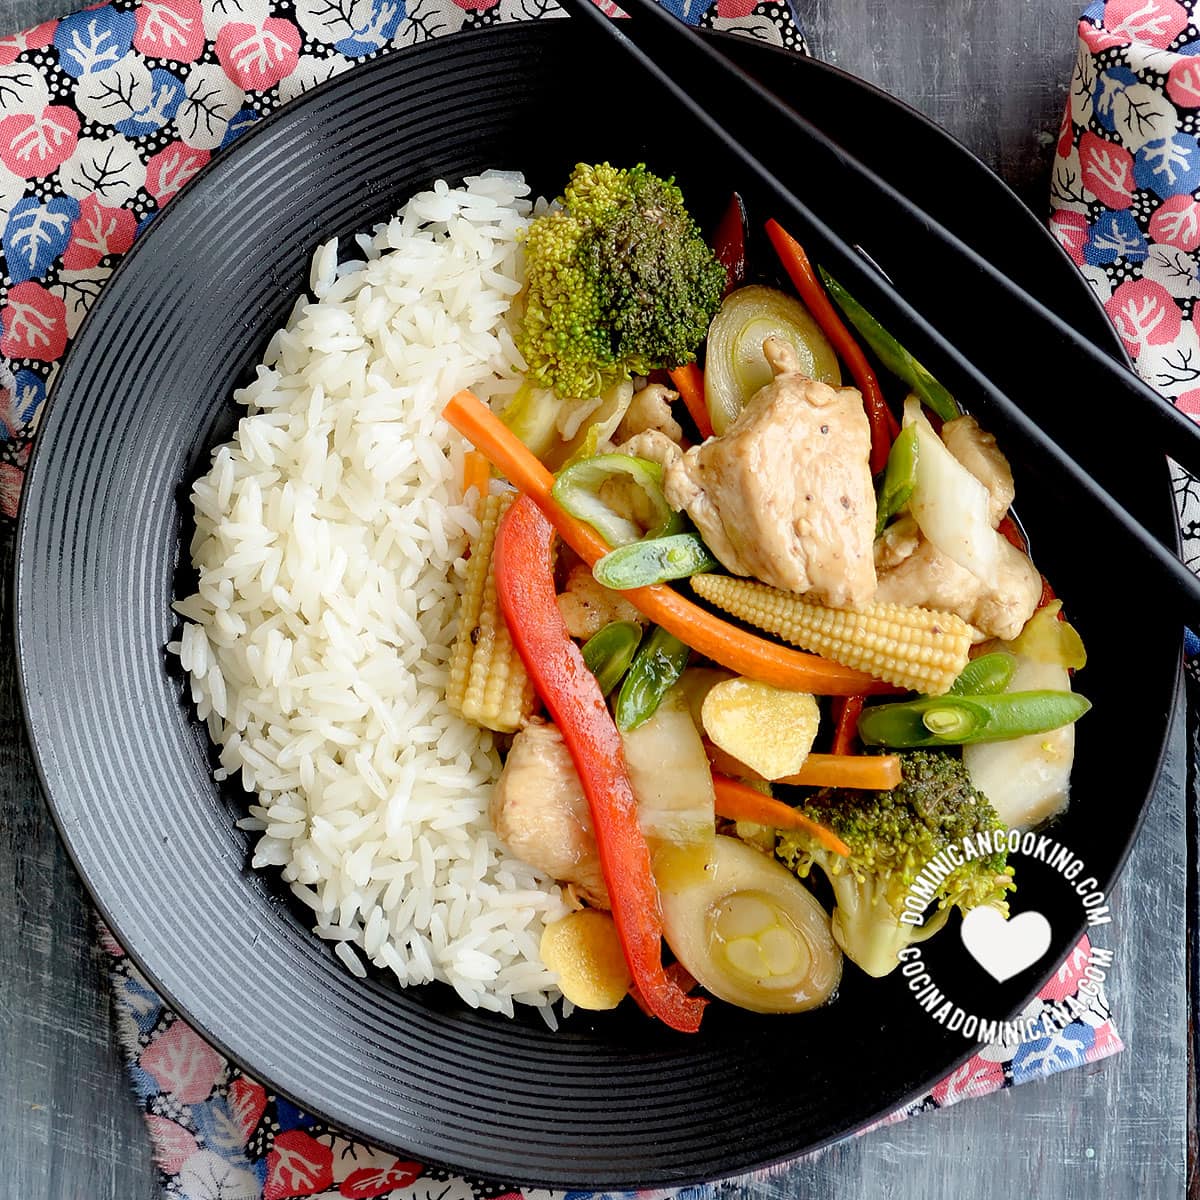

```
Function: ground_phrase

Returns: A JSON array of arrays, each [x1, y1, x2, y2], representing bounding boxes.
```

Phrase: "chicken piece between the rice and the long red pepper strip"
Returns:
[[487, 721, 610, 908]]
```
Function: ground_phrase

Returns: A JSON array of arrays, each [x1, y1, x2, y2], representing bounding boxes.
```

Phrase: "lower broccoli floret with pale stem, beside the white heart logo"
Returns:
[[775, 750, 1015, 977]]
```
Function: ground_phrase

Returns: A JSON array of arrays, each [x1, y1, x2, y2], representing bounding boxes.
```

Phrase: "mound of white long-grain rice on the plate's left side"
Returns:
[[170, 173, 566, 1021]]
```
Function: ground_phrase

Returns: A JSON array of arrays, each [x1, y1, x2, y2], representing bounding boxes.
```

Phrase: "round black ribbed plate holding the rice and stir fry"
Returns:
[[16, 22, 1178, 1187]]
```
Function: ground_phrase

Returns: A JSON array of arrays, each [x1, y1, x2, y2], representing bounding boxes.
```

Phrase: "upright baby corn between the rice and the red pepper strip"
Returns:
[[446, 492, 534, 733]]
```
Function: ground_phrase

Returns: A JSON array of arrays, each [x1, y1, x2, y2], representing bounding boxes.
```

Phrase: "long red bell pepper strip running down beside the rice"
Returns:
[[496, 496, 707, 1033]]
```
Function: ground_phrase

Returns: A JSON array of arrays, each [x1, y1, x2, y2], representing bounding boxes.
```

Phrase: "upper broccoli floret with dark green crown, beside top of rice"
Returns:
[[517, 163, 725, 398]]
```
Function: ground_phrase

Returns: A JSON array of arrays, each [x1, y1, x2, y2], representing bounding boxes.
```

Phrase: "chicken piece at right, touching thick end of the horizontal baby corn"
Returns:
[[875, 534, 1042, 641]]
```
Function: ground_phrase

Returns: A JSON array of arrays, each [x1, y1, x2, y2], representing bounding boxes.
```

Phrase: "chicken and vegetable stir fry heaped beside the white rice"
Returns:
[[445, 164, 1088, 1031]]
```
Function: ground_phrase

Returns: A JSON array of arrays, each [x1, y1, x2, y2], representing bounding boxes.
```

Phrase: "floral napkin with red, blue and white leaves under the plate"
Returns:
[[0, 0, 1185, 1200]]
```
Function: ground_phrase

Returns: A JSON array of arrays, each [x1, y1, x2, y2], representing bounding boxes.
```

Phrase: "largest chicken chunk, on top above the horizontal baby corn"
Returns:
[[664, 337, 875, 608]]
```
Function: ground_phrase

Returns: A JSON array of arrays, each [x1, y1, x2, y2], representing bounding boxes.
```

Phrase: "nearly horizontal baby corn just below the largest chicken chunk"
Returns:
[[691, 575, 974, 696]]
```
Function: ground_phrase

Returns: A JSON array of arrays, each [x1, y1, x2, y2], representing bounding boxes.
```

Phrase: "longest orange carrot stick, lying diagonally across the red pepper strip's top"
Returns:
[[442, 391, 895, 696]]
